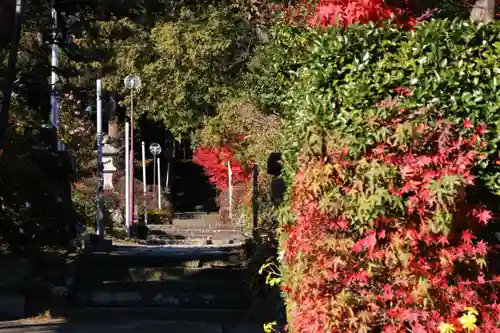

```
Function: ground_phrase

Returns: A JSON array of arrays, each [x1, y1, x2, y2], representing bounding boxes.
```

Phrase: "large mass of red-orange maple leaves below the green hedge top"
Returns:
[[283, 119, 500, 333]]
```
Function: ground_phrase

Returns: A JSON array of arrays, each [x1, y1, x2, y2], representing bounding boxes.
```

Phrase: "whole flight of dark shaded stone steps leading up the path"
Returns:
[[70, 243, 252, 323]]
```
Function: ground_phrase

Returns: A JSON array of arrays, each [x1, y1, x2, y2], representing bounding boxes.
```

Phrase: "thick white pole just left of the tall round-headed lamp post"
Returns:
[[96, 79, 104, 238]]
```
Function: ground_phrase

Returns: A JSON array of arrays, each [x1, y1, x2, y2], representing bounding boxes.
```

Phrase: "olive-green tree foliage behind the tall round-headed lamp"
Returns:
[[95, 5, 254, 135]]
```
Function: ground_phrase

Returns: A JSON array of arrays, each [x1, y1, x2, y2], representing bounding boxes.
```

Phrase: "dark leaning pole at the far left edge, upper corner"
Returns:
[[0, 0, 24, 156]]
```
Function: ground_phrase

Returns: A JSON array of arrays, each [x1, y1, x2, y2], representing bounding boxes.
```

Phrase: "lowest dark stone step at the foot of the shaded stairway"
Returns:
[[68, 306, 252, 323]]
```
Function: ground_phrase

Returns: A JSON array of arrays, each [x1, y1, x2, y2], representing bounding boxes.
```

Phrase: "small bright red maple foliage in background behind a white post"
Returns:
[[193, 146, 249, 191]]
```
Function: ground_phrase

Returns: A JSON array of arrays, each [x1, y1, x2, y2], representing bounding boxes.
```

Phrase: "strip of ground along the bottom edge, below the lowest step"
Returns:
[[0, 321, 263, 333]]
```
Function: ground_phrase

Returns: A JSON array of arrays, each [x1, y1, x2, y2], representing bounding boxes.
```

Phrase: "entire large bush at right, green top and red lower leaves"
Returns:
[[280, 20, 500, 333]]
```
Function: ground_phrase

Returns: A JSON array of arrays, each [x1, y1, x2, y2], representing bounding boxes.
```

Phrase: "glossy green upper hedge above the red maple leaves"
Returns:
[[278, 20, 500, 193]]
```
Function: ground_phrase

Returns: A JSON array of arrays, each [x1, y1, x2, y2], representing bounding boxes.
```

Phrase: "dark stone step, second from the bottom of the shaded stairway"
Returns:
[[76, 289, 251, 309]]
